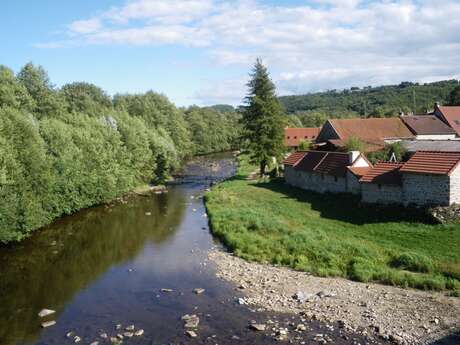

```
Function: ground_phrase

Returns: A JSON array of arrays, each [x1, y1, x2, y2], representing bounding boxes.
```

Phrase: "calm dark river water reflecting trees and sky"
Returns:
[[0, 154, 388, 345]]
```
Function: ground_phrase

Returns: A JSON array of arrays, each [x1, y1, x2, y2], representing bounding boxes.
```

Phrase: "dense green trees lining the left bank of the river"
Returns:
[[0, 63, 240, 243]]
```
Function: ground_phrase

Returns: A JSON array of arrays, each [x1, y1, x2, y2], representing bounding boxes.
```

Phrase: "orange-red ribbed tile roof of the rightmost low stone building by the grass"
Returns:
[[401, 151, 460, 175]]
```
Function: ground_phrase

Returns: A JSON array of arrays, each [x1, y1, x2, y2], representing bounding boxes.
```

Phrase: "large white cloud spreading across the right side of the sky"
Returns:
[[35, 0, 460, 102]]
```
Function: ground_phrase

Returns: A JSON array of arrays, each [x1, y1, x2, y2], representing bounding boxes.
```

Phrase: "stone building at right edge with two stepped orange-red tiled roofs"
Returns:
[[360, 151, 460, 206]]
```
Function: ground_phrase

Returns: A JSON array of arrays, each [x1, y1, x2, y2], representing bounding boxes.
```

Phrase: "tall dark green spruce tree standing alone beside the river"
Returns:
[[242, 59, 284, 175]]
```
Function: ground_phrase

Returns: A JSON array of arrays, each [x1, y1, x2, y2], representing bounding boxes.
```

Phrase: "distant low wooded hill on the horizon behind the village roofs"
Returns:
[[279, 80, 459, 117]]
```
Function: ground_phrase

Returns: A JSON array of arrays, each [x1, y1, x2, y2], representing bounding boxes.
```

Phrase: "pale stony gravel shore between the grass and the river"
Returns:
[[209, 250, 460, 345]]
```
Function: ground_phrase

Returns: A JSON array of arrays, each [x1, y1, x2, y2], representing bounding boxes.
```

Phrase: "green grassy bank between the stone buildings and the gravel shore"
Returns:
[[206, 156, 460, 295]]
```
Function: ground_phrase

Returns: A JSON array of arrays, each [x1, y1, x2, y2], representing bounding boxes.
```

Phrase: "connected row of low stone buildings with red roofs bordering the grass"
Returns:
[[283, 151, 460, 206]]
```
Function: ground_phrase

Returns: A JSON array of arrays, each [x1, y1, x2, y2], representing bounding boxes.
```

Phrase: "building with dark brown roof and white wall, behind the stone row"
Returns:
[[401, 115, 457, 140]]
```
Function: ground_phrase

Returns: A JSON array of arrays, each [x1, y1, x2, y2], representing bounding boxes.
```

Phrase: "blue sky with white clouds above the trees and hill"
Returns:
[[0, 0, 460, 105]]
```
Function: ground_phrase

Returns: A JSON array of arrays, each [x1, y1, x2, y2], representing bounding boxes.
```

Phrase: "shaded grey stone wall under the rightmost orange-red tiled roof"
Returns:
[[402, 173, 450, 206]]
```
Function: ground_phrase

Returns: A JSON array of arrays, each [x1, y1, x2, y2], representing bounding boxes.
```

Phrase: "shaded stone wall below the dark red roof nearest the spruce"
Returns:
[[284, 166, 347, 193]]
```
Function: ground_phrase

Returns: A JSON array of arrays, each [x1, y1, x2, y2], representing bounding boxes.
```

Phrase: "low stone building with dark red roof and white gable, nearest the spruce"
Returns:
[[283, 151, 371, 194]]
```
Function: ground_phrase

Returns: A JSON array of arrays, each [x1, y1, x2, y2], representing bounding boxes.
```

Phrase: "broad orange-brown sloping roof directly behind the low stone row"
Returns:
[[329, 117, 414, 141]]
